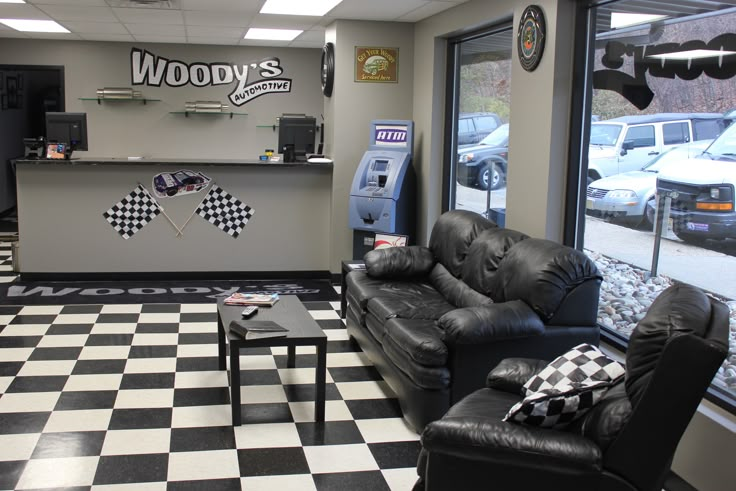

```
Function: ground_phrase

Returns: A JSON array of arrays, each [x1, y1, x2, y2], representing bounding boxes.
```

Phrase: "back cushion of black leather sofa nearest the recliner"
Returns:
[[490, 238, 602, 322]]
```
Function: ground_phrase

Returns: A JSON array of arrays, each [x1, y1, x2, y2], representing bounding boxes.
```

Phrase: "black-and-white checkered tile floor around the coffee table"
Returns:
[[0, 290, 420, 491]]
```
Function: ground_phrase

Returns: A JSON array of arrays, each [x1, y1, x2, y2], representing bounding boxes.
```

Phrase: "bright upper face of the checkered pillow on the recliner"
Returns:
[[522, 344, 625, 396]]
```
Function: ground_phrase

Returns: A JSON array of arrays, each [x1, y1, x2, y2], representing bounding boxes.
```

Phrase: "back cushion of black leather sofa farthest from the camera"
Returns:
[[429, 210, 498, 278]]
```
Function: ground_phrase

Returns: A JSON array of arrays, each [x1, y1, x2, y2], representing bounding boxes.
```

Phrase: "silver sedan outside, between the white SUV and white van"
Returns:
[[585, 140, 712, 226]]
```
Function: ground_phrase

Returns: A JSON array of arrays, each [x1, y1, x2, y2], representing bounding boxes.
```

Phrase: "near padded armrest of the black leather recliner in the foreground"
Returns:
[[422, 416, 602, 470]]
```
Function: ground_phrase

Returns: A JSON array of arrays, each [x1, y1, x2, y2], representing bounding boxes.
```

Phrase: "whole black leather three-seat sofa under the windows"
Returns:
[[346, 210, 601, 431]]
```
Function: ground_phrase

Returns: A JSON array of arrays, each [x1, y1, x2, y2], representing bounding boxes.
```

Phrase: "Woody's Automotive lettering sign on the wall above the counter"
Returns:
[[130, 48, 292, 106]]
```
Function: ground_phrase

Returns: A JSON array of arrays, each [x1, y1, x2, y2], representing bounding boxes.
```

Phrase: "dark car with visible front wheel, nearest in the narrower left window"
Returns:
[[457, 123, 509, 189]]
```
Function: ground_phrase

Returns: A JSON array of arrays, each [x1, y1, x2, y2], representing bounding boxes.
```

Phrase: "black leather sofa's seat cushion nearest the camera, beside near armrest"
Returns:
[[384, 318, 447, 367]]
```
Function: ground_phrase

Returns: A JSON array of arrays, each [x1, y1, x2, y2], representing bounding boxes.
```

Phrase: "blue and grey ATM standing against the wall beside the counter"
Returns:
[[349, 120, 416, 259]]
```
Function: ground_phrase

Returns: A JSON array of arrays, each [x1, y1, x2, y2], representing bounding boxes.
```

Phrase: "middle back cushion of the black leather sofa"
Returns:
[[461, 228, 529, 296]]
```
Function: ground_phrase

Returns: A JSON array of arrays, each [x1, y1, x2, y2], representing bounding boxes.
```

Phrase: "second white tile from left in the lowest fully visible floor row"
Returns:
[[168, 450, 240, 481]]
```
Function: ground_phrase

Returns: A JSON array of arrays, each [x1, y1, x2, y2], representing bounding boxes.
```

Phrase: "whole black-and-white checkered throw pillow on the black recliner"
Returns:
[[504, 344, 625, 428]]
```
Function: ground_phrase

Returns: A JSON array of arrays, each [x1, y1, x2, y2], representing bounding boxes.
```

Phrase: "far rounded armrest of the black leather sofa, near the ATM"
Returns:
[[363, 246, 435, 278]]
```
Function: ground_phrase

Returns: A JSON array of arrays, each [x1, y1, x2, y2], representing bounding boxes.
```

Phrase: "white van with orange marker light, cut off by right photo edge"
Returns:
[[657, 124, 736, 244]]
